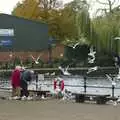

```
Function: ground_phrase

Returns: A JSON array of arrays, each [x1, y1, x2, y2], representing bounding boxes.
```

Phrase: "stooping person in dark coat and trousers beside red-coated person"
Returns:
[[21, 69, 33, 97]]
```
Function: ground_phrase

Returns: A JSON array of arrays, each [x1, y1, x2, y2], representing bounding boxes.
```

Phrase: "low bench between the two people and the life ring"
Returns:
[[28, 90, 50, 97]]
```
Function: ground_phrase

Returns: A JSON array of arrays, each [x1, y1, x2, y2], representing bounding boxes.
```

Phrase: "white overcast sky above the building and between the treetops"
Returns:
[[0, 0, 120, 15]]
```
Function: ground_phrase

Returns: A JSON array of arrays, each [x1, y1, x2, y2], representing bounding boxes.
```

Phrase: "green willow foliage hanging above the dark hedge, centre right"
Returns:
[[64, 0, 90, 46]]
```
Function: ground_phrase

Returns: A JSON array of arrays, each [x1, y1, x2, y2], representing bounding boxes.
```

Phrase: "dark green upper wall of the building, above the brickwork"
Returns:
[[0, 14, 49, 51]]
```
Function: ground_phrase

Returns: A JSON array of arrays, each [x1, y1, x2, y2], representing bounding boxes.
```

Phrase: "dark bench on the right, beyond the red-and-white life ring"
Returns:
[[73, 93, 110, 104]]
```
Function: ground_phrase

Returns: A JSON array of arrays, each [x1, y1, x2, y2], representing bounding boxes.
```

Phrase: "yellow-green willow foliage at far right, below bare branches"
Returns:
[[93, 10, 120, 52]]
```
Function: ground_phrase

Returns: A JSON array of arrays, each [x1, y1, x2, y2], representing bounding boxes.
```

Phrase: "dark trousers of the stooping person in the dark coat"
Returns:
[[21, 81, 29, 97]]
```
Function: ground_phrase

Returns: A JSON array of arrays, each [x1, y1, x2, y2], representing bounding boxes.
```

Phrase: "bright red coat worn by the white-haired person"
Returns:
[[11, 69, 20, 88]]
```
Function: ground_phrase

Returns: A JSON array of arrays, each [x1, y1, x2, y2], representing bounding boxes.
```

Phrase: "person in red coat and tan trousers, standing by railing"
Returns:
[[11, 66, 21, 99]]
